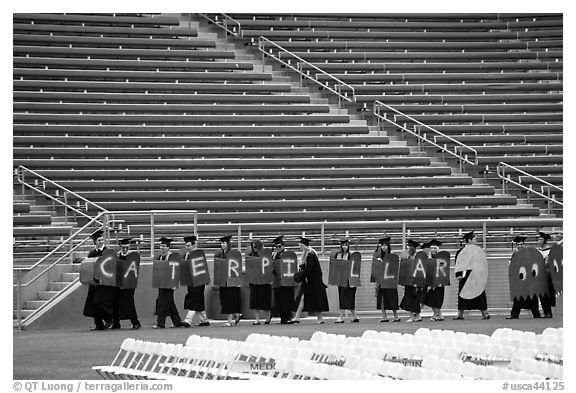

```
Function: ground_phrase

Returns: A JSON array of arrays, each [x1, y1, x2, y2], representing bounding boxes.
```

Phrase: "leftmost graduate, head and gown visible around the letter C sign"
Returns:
[[83, 229, 114, 330]]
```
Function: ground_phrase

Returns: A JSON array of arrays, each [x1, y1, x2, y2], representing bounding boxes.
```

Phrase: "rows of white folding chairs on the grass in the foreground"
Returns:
[[93, 328, 563, 380]]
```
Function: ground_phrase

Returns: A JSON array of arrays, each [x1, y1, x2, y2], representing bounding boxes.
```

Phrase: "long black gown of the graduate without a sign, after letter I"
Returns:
[[296, 252, 329, 312]]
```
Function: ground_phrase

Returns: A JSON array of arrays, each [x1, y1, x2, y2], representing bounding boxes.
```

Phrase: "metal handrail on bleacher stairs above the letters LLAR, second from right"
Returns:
[[373, 100, 478, 169]]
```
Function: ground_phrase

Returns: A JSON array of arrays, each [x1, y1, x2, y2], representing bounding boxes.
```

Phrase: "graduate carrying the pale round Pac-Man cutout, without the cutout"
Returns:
[[452, 231, 490, 320]]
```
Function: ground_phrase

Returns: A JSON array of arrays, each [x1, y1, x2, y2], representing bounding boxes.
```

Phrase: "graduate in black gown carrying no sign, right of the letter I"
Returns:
[[292, 237, 329, 324]]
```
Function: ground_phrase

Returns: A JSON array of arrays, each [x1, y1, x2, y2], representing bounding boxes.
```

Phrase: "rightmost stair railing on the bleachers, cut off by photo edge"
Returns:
[[496, 161, 564, 214]]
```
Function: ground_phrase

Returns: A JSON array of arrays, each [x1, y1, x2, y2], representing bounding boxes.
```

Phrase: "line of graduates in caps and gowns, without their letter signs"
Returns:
[[84, 230, 555, 330]]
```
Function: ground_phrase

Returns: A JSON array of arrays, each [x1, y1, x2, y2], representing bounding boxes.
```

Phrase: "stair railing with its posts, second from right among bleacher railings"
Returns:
[[373, 101, 478, 172]]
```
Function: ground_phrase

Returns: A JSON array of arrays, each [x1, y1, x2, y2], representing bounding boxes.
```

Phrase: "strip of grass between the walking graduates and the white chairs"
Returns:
[[13, 311, 563, 380]]
